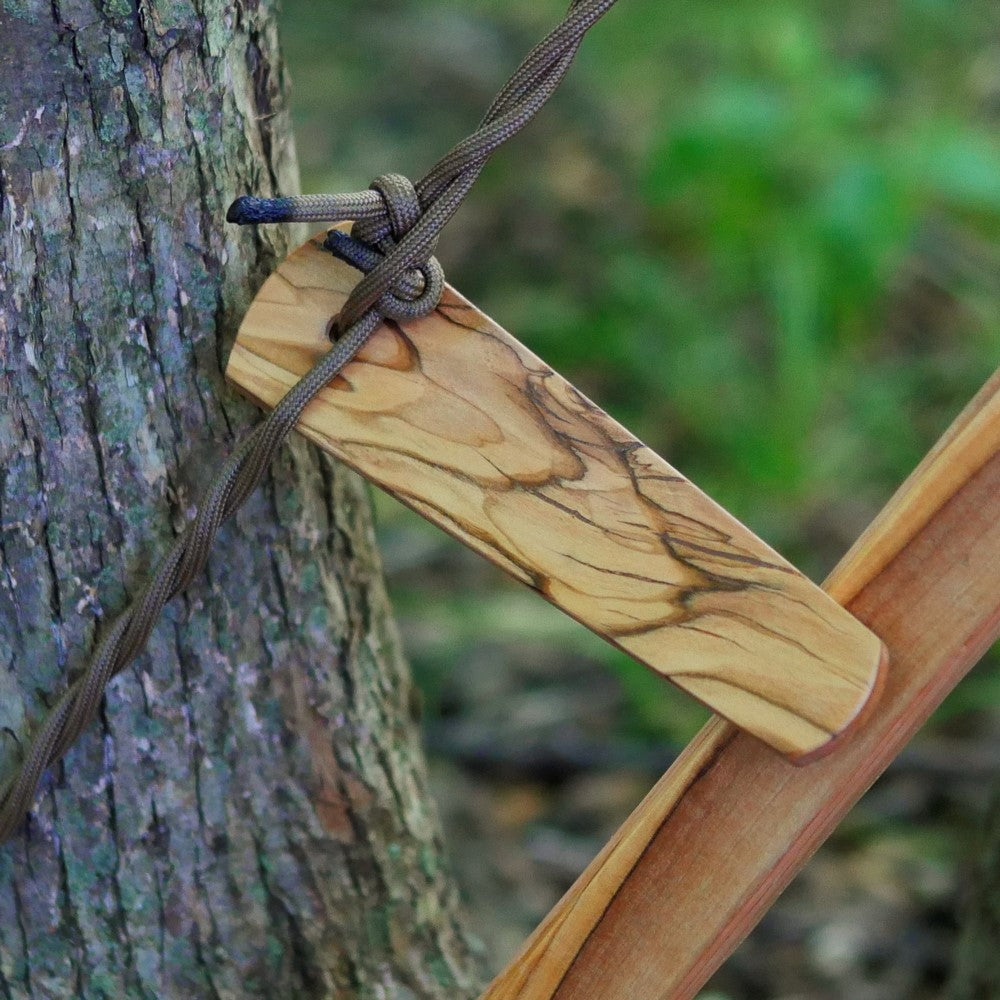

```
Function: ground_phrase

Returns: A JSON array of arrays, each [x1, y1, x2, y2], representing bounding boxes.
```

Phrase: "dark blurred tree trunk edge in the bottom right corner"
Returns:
[[947, 786, 1000, 1000]]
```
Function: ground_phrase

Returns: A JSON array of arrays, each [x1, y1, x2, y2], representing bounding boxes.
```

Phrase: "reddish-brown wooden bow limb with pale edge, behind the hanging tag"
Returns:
[[483, 373, 1000, 1000]]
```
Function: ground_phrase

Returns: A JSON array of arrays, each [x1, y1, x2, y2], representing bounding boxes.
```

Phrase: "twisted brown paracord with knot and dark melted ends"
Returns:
[[0, 0, 617, 843]]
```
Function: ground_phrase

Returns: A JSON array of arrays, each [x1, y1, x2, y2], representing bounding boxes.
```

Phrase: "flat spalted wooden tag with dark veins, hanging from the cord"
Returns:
[[227, 237, 883, 757]]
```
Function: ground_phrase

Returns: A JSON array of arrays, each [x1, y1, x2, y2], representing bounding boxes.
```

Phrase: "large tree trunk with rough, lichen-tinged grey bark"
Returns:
[[0, 0, 484, 1000]]
